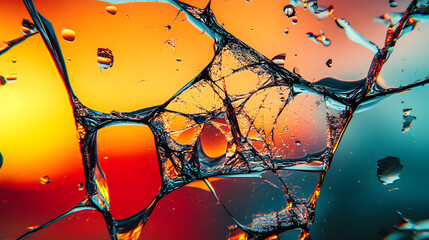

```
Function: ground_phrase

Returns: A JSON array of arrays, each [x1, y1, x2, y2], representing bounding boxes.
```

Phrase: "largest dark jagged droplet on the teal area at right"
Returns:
[[377, 156, 403, 185]]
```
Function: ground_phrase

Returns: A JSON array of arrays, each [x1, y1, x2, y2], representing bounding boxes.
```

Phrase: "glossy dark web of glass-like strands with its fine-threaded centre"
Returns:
[[0, 0, 429, 240]]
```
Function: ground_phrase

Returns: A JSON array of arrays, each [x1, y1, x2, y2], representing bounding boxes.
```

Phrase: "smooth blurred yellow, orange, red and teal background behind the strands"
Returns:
[[0, 0, 429, 239]]
